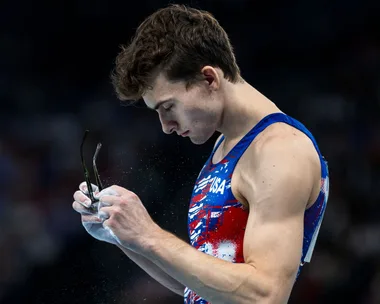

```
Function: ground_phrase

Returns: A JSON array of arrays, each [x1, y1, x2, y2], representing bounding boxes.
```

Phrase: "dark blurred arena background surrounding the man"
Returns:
[[0, 0, 380, 304]]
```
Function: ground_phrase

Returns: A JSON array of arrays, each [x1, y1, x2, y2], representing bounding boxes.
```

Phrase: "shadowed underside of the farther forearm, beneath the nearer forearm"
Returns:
[[118, 246, 185, 297]]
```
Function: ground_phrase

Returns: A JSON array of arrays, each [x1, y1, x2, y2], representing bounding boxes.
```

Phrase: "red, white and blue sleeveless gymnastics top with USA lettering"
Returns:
[[184, 113, 329, 304]]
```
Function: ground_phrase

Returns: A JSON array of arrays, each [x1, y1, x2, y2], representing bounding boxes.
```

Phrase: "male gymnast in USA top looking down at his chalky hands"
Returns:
[[73, 5, 329, 304]]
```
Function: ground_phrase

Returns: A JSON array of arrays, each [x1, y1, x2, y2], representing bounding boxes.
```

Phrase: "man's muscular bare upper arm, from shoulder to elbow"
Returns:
[[242, 136, 315, 295]]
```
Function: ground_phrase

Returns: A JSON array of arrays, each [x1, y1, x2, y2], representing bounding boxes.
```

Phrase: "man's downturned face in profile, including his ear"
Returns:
[[143, 67, 222, 145]]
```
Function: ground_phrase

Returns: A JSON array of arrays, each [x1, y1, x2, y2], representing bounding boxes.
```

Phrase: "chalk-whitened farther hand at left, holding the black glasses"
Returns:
[[73, 182, 119, 245]]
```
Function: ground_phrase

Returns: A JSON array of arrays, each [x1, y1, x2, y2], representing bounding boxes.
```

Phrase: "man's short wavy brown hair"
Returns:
[[111, 4, 240, 100]]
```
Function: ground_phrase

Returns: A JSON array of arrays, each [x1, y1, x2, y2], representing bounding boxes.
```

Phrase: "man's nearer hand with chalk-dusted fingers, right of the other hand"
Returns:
[[95, 185, 162, 254]]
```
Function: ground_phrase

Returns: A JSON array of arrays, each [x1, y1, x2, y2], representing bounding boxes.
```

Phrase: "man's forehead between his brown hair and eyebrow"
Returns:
[[142, 73, 185, 107]]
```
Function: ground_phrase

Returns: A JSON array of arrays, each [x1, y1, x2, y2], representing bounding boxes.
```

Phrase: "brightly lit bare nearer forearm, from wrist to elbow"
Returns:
[[144, 231, 271, 304]]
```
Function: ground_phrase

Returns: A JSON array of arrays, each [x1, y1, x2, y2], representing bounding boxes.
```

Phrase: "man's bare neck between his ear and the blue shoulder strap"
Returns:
[[217, 81, 281, 141]]
